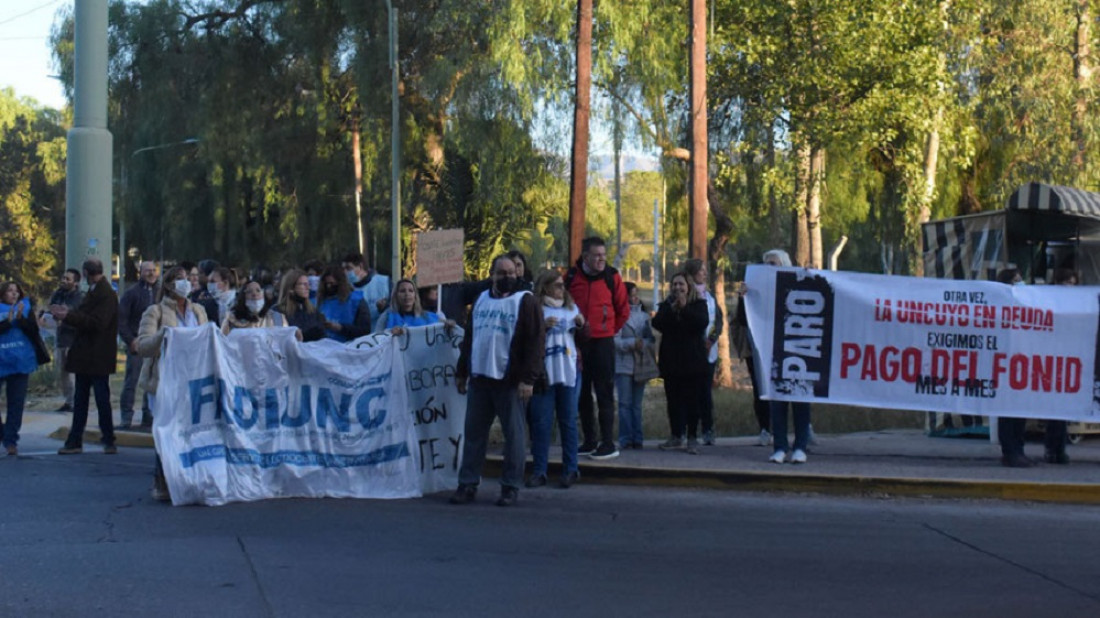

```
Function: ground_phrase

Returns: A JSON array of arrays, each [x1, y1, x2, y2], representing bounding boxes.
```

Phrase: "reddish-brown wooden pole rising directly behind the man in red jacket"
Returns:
[[569, 0, 592, 264]]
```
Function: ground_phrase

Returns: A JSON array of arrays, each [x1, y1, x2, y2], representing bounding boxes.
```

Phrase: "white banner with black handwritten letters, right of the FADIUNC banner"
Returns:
[[350, 323, 466, 494]]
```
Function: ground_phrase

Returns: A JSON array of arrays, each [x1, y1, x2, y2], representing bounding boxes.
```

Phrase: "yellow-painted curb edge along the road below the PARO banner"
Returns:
[[485, 455, 1100, 505]]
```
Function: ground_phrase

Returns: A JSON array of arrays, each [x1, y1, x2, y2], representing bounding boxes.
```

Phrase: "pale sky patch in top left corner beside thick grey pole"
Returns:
[[0, 0, 73, 109]]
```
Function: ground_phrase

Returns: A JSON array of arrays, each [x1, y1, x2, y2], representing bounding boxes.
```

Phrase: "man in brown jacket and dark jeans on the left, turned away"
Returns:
[[50, 257, 119, 455]]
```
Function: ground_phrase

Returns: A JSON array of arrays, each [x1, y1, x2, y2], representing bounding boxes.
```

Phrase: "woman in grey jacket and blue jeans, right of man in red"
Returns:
[[615, 282, 657, 449]]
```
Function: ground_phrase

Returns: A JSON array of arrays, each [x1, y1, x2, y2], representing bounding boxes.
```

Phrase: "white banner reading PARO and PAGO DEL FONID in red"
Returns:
[[745, 266, 1100, 422]]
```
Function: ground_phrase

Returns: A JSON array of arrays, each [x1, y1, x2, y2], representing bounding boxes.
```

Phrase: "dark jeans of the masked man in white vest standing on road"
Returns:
[[459, 377, 527, 489]]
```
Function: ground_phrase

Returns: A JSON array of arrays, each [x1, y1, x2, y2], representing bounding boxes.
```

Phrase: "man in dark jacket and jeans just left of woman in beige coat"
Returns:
[[119, 262, 157, 429]]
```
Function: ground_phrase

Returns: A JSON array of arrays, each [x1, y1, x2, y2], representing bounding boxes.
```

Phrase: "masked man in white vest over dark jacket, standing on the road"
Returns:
[[451, 255, 546, 507]]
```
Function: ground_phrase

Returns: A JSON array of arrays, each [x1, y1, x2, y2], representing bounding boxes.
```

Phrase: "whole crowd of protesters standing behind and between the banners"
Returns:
[[0, 236, 1076, 506]]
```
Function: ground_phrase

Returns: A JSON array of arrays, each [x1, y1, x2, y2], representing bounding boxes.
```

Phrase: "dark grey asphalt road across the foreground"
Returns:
[[0, 446, 1100, 618]]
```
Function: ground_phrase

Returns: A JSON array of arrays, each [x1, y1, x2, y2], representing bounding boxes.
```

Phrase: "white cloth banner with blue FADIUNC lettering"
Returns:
[[159, 324, 420, 505]]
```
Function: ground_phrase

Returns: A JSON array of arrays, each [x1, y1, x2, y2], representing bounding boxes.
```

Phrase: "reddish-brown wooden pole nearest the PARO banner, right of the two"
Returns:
[[688, 0, 707, 260]]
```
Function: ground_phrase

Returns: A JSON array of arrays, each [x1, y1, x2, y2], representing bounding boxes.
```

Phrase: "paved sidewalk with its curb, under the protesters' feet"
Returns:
[[20, 410, 1100, 504]]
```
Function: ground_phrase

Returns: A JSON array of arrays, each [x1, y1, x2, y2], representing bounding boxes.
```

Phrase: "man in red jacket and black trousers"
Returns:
[[565, 236, 630, 460]]
